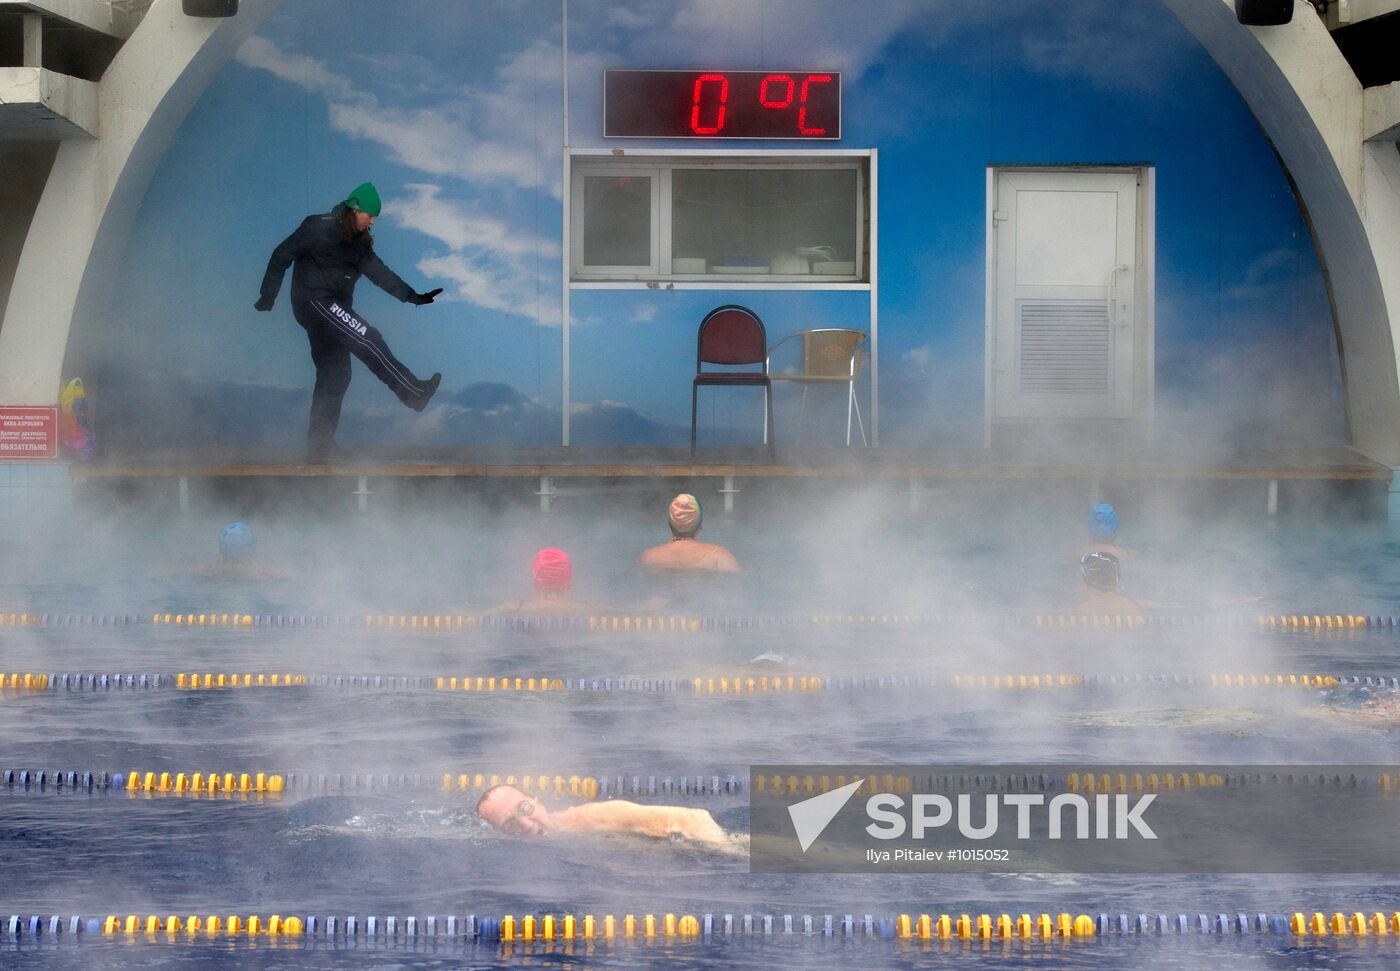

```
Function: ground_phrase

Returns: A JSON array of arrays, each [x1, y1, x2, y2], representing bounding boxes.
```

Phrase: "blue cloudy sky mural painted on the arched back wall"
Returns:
[[90, 0, 1343, 448]]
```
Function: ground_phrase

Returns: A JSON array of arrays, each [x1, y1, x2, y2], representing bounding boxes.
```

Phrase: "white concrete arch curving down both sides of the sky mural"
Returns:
[[0, 0, 1400, 466]]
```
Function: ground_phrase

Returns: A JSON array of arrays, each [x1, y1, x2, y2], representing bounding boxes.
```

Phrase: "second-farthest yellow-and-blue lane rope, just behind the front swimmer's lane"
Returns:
[[0, 672, 1400, 697]]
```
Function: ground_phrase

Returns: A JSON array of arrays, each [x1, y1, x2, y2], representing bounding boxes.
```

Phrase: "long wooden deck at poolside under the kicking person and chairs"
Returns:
[[71, 446, 1392, 481]]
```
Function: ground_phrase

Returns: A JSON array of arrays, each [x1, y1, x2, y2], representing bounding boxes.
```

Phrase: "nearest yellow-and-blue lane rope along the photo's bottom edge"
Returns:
[[4, 911, 1400, 946]]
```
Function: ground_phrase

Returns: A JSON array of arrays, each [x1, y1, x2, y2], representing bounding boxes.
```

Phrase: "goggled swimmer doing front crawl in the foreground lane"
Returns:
[[476, 785, 731, 846]]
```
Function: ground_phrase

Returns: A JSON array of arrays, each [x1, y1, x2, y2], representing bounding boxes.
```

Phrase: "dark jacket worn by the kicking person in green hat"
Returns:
[[262, 206, 414, 306]]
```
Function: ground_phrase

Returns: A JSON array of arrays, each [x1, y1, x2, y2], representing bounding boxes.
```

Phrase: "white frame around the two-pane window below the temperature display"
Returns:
[[566, 148, 875, 290]]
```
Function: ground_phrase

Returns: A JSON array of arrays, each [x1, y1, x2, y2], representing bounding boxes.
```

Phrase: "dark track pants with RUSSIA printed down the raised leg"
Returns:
[[293, 299, 427, 452]]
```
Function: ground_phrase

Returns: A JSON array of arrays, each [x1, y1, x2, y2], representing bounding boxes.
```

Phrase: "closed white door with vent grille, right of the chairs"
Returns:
[[987, 171, 1145, 421]]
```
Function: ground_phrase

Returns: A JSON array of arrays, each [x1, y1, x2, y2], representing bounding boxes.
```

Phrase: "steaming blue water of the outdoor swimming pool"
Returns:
[[0, 497, 1400, 967]]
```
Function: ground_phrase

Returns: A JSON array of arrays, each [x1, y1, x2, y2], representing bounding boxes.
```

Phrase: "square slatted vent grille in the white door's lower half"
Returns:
[[1016, 299, 1113, 396]]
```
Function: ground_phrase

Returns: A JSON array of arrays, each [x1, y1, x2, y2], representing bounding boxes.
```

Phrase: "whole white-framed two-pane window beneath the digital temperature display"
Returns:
[[571, 155, 868, 285]]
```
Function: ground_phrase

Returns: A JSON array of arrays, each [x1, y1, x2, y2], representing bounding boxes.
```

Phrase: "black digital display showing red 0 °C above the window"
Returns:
[[603, 70, 841, 140]]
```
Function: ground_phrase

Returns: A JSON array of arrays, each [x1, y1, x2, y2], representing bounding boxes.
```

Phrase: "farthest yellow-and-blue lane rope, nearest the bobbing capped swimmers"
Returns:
[[0, 611, 1400, 634]]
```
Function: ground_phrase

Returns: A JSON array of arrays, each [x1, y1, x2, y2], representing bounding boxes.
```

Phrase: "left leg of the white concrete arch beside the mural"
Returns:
[[0, 0, 277, 404]]
